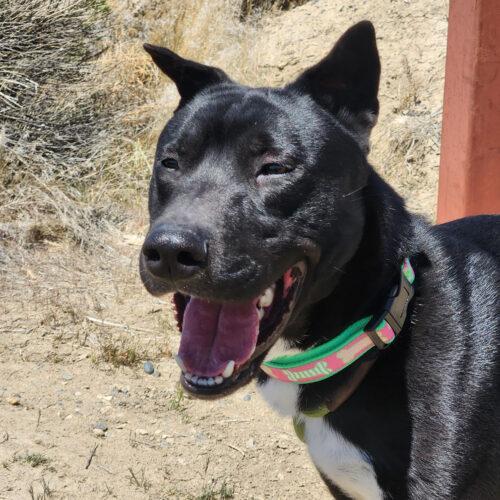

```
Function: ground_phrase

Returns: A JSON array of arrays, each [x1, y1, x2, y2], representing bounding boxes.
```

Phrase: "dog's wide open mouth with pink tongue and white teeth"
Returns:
[[174, 262, 306, 397]]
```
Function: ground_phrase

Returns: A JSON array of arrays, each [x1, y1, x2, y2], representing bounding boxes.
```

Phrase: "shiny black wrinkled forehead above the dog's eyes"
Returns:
[[164, 85, 307, 154]]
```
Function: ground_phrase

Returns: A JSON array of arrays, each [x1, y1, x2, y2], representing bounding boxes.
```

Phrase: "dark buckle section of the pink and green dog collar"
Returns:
[[365, 264, 415, 350]]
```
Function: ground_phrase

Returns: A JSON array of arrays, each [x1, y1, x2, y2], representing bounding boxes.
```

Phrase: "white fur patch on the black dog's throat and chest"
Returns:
[[259, 345, 383, 500]]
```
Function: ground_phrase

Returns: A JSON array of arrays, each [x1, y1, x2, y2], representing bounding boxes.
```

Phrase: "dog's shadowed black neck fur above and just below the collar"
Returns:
[[270, 171, 413, 408]]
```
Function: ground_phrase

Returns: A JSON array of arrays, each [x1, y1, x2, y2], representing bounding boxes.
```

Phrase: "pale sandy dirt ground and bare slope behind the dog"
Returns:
[[0, 0, 447, 500]]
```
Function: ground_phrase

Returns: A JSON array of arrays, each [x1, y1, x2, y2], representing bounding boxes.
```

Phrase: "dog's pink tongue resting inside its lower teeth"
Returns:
[[179, 297, 259, 377]]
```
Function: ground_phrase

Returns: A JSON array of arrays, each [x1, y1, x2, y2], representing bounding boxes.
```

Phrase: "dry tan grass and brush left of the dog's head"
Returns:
[[0, 0, 264, 267]]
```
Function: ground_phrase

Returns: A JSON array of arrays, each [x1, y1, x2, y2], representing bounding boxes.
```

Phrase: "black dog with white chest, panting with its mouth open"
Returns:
[[140, 22, 500, 500]]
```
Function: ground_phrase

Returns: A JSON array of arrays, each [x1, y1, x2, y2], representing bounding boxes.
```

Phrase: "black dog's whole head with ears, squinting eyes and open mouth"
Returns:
[[140, 21, 380, 397]]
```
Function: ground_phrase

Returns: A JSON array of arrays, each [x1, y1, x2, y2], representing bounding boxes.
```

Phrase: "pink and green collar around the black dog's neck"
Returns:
[[261, 259, 415, 384]]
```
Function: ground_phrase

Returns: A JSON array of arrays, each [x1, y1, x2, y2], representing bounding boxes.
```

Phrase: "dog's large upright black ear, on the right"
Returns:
[[290, 21, 380, 150]]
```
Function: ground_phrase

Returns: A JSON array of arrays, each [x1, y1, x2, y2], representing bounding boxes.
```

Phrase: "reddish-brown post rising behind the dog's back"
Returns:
[[437, 0, 500, 222]]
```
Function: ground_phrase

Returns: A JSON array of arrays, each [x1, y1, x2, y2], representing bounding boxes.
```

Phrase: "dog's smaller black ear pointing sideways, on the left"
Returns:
[[144, 43, 230, 107]]
